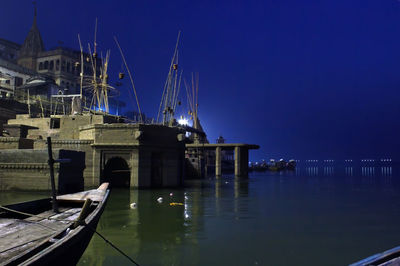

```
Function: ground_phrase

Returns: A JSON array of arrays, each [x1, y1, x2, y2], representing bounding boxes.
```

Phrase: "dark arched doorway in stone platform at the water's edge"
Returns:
[[102, 157, 131, 187]]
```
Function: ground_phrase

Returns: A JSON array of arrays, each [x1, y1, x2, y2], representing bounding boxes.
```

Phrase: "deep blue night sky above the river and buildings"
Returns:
[[0, 0, 400, 160]]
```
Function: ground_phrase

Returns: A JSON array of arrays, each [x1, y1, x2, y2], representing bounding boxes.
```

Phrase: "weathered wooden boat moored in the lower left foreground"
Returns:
[[0, 183, 109, 265]]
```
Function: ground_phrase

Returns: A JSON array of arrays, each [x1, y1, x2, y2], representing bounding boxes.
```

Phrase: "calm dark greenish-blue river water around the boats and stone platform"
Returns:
[[0, 165, 400, 265]]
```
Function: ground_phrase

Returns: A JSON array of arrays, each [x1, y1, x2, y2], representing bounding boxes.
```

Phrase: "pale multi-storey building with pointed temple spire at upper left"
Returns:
[[0, 8, 97, 101]]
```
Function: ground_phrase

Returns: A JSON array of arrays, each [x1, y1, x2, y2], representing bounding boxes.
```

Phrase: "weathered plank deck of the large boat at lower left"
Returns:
[[0, 184, 108, 265]]
